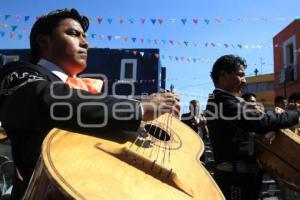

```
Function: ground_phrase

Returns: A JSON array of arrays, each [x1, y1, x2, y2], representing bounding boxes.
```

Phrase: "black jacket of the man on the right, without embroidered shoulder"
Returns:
[[205, 89, 299, 163]]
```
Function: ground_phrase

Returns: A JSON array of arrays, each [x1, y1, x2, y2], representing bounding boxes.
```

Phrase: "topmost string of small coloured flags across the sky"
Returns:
[[0, 14, 300, 25]]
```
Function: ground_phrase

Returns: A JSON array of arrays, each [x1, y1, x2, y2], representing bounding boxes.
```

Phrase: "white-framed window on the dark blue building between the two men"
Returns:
[[120, 59, 137, 81]]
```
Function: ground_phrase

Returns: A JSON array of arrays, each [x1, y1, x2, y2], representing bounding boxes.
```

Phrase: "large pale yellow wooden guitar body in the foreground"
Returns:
[[25, 114, 225, 200]]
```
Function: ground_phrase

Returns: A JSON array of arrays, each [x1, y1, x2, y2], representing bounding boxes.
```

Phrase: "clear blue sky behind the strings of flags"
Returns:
[[0, 0, 300, 111]]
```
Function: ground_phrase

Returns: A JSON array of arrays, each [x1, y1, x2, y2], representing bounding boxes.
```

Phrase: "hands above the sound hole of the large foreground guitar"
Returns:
[[141, 92, 180, 121]]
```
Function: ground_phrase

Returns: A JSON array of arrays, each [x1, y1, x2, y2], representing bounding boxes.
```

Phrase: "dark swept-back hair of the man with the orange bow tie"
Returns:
[[30, 8, 90, 63]]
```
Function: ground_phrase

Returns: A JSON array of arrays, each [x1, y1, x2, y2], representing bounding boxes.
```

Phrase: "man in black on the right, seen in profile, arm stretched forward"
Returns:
[[206, 55, 299, 200]]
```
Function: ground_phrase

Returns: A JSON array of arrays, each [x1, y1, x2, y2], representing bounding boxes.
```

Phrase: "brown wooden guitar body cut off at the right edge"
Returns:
[[256, 129, 300, 192]]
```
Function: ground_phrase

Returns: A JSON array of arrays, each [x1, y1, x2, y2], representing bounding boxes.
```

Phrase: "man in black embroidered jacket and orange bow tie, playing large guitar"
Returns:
[[0, 9, 179, 199]]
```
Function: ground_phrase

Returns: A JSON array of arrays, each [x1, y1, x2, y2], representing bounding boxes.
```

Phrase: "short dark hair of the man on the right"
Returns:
[[210, 55, 247, 85]]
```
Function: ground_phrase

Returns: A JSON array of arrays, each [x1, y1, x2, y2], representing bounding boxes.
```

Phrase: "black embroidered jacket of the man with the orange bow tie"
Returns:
[[0, 62, 142, 199]]
